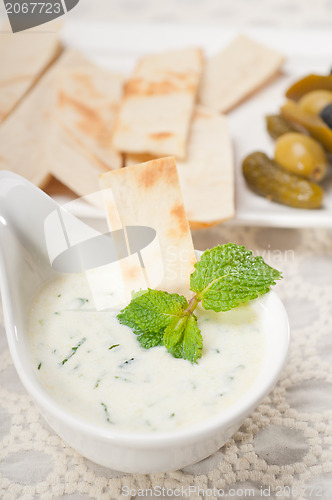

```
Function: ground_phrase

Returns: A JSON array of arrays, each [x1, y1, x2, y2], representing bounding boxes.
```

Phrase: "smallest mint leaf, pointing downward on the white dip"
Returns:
[[164, 314, 203, 363]]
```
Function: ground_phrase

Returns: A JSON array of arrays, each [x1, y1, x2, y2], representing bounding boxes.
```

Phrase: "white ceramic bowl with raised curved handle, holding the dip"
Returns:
[[0, 172, 289, 473]]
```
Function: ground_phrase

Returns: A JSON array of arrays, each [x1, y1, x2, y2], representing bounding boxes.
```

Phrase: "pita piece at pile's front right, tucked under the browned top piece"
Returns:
[[125, 106, 234, 229]]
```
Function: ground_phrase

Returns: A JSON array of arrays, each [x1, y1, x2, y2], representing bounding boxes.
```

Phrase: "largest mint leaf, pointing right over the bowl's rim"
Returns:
[[190, 243, 282, 312]]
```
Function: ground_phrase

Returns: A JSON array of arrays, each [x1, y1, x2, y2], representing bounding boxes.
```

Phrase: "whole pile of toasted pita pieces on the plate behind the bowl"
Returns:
[[0, 29, 283, 228]]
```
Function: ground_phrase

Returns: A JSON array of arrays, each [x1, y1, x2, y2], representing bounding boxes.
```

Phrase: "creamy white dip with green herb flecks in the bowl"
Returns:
[[29, 274, 265, 432]]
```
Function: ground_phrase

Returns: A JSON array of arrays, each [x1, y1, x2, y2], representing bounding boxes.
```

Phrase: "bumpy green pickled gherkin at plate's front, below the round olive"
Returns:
[[242, 152, 324, 208]]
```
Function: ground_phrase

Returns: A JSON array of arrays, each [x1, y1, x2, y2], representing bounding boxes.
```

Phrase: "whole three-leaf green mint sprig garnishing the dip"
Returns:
[[117, 243, 282, 363]]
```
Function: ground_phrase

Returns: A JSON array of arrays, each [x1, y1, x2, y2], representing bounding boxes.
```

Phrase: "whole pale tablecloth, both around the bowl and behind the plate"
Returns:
[[0, 0, 332, 500]]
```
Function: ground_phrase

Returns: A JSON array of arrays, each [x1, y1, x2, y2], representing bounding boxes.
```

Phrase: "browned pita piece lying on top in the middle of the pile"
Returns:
[[113, 49, 203, 158]]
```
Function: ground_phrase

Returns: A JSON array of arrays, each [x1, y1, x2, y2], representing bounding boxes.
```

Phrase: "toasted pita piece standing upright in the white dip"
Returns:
[[100, 158, 196, 295]]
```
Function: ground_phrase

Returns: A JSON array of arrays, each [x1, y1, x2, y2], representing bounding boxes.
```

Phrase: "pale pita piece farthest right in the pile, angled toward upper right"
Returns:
[[200, 35, 284, 113]]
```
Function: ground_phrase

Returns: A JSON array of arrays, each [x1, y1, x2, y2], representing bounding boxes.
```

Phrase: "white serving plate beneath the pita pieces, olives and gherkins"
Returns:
[[56, 22, 332, 227]]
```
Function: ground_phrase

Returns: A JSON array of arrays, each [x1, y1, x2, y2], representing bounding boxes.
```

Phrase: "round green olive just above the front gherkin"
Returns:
[[274, 132, 327, 181]]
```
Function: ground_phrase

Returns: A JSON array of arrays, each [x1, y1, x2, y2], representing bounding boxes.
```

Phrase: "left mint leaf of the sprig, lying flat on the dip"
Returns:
[[117, 289, 188, 349]]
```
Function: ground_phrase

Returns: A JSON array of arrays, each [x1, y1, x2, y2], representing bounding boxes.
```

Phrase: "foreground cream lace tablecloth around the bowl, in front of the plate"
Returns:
[[0, 226, 332, 500]]
